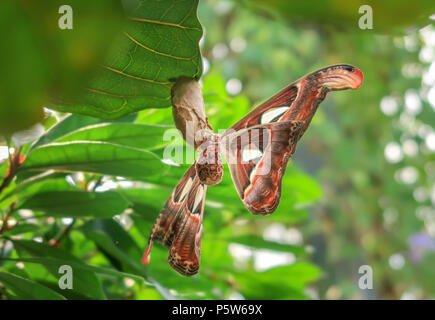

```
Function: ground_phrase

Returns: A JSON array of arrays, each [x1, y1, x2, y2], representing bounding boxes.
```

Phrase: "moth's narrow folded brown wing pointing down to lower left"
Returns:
[[142, 165, 207, 276]]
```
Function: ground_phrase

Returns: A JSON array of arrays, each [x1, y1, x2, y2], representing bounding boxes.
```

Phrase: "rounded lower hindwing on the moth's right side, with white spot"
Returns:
[[225, 121, 305, 215]]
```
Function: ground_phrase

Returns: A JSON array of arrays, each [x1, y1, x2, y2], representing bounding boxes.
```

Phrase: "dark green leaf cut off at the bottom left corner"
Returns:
[[0, 272, 65, 300]]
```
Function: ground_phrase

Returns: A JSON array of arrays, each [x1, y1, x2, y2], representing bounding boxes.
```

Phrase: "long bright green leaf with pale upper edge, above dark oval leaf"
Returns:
[[20, 141, 166, 179]]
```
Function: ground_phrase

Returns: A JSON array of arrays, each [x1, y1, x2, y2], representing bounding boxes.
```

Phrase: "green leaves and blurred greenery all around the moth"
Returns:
[[0, 0, 435, 299]]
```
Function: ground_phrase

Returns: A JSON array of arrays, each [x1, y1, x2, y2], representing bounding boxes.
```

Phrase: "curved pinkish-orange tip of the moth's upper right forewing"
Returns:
[[307, 64, 364, 91]]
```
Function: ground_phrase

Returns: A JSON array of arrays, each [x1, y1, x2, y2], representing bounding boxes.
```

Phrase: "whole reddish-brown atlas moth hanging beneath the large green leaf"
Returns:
[[142, 64, 363, 276]]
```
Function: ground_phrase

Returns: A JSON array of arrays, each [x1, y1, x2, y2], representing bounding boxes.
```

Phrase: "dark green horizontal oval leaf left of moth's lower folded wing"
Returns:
[[19, 191, 129, 218]]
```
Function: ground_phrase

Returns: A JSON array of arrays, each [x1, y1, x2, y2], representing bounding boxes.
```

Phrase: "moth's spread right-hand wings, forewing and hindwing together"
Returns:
[[222, 64, 363, 215]]
